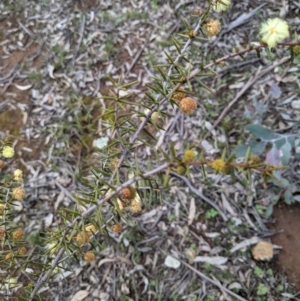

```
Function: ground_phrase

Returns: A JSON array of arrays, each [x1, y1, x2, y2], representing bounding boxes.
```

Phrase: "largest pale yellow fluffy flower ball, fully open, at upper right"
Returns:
[[259, 18, 290, 48]]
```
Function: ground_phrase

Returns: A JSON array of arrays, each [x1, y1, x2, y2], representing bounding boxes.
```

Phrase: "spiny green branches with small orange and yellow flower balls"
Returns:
[[0, 1, 299, 300]]
